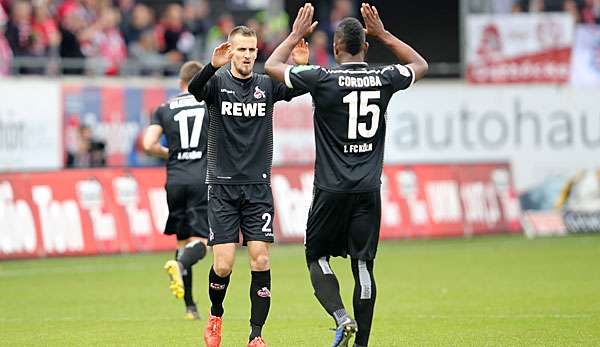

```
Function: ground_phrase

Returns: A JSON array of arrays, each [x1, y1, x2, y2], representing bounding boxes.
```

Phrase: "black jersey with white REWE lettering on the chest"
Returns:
[[190, 67, 306, 184]]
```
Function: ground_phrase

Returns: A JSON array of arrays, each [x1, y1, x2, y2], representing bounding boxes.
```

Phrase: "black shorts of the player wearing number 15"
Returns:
[[304, 187, 381, 261]]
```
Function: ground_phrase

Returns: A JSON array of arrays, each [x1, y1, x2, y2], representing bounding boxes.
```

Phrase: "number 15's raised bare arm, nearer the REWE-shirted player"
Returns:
[[265, 3, 318, 82]]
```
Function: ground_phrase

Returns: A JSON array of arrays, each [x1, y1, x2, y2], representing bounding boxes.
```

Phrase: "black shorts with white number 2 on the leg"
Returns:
[[208, 184, 275, 246]]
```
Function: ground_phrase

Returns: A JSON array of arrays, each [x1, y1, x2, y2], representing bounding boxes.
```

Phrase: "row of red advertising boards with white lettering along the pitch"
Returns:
[[0, 163, 520, 259]]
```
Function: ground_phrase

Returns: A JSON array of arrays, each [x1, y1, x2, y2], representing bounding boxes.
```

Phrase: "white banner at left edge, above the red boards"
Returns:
[[0, 79, 63, 172]]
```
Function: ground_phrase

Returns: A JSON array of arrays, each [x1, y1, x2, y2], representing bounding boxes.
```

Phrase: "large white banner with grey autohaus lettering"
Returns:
[[385, 83, 600, 191]]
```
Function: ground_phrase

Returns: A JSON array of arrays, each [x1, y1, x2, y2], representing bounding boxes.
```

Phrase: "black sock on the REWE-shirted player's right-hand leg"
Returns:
[[249, 270, 271, 341]]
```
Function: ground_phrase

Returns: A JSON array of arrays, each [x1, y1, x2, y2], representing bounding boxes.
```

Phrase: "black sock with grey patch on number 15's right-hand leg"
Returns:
[[351, 259, 377, 346]]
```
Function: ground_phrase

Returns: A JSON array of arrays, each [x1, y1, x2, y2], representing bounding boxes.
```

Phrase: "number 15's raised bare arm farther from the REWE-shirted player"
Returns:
[[360, 3, 429, 81]]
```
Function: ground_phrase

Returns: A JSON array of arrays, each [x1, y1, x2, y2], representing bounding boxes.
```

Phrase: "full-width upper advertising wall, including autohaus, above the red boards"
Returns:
[[0, 79, 600, 193]]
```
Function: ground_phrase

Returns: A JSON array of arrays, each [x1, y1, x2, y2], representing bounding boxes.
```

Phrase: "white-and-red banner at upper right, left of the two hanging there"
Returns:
[[465, 13, 575, 83]]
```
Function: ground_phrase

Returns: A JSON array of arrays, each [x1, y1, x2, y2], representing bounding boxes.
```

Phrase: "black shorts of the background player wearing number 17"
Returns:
[[164, 183, 208, 240]]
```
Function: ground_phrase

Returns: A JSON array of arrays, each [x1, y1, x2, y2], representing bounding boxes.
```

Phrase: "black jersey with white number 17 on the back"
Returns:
[[151, 93, 208, 184]]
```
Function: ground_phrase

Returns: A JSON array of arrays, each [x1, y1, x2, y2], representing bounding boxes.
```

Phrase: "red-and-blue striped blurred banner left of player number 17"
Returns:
[[62, 83, 178, 166]]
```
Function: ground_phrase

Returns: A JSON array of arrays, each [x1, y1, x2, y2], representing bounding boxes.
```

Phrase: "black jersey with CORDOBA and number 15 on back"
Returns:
[[285, 62, 415, 192]]
